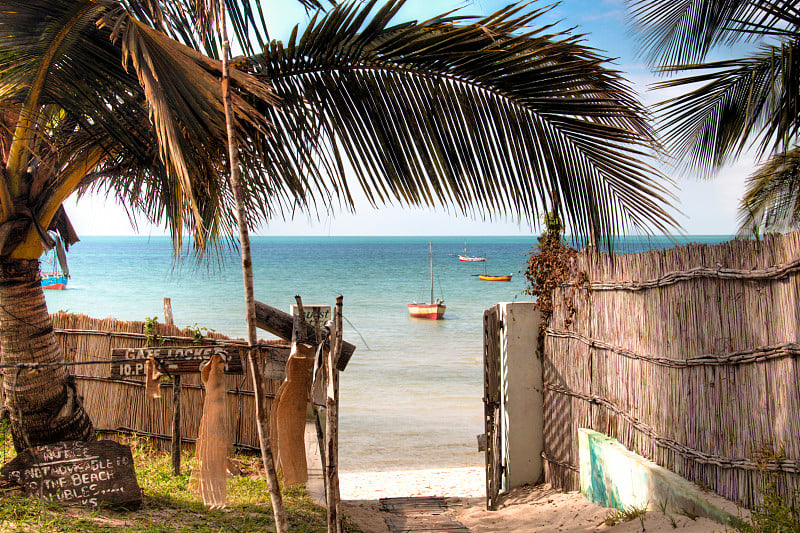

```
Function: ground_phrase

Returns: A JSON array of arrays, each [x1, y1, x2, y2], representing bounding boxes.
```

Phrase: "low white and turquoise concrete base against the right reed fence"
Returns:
[[578, 428, 740, 527]]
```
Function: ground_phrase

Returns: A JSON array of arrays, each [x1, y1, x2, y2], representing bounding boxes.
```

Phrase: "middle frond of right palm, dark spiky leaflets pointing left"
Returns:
[[656, 43, 800, 174]]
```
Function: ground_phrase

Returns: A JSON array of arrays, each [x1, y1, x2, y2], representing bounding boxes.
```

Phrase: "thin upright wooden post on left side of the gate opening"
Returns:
[[323, 296, 342, 533]]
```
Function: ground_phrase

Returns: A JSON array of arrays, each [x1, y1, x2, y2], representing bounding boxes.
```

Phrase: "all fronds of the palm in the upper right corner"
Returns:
[[631, 0, 800, 234]]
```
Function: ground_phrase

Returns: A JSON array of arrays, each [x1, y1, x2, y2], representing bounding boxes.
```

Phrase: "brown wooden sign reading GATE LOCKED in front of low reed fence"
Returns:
[[111, 346, 247, 379]]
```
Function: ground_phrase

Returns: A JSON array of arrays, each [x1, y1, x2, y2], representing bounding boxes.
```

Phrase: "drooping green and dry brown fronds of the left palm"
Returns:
[[0, 0, 286, 255]]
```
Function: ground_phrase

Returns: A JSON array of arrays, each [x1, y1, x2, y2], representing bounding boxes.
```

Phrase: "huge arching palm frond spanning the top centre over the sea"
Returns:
[[254, 0, 675, 241]]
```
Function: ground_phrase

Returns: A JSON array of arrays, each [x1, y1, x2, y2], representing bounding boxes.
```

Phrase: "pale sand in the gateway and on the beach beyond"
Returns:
[[340, 467, 725, 533]]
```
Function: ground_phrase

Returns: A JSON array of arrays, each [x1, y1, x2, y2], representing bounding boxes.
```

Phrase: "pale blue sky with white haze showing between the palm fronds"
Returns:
[[66, 0, 753, 235]]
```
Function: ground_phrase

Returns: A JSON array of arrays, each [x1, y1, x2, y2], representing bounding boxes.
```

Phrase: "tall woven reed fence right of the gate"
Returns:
[[544, 233, 800, 507]]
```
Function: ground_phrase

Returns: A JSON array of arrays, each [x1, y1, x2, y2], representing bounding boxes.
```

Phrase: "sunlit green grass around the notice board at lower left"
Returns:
[[0, 435, 360, 533]]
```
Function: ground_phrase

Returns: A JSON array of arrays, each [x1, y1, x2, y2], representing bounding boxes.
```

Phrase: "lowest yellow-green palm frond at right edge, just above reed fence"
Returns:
[[739, 147, 800, 235]]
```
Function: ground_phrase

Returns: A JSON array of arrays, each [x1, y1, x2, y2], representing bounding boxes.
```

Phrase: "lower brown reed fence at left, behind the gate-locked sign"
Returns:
[[45, 313, 285, 450]]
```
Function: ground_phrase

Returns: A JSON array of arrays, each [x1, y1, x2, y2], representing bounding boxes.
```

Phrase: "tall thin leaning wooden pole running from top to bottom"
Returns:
[[219, 0, 289, 533]]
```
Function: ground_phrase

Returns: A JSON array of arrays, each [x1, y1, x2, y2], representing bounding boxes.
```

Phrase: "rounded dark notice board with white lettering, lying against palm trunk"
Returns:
[[0, 440, 142, 509]]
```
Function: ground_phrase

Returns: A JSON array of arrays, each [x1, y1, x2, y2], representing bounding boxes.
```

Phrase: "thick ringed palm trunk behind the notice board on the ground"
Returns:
[[0, 260, 95, 451]]
